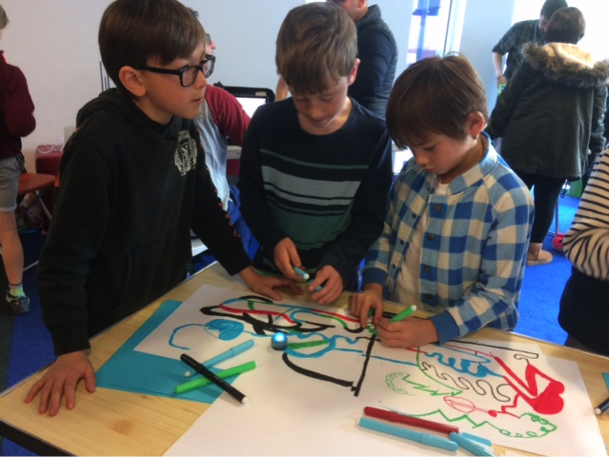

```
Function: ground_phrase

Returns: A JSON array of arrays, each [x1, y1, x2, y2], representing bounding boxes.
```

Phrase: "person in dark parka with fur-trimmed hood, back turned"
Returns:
[[488, 7, 608, 266]]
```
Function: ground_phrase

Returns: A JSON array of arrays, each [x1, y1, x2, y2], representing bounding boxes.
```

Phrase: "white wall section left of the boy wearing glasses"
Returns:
[[0, 0, 110, 171]]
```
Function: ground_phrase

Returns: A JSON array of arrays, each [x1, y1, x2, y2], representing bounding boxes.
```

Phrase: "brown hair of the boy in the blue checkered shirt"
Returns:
[[386, 55, 487, 148]]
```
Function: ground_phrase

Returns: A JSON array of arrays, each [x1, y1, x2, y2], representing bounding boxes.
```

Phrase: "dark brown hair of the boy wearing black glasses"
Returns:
[[98, 0, 205, 97]]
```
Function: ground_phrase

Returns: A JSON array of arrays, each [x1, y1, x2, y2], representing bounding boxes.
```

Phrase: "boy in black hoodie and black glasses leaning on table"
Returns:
[[25, 0, 300, 416]]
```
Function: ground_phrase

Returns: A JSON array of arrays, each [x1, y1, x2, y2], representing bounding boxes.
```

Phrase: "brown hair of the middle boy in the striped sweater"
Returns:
[[275, 2, 358, 94]]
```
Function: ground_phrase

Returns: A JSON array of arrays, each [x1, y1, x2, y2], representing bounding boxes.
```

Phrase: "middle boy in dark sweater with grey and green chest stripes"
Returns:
[[238, 2, 392, 304]]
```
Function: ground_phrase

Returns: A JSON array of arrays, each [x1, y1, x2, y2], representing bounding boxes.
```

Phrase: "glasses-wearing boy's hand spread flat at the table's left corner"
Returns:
[[25, 351, 95, 417]]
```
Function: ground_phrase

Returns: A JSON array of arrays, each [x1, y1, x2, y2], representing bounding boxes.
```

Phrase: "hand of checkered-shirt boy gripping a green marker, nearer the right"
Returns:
[[377, 317, 438, 348]]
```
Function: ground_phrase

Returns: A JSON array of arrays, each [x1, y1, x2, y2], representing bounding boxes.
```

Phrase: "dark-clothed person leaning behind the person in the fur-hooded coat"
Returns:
[[491, 0, 568, 91]]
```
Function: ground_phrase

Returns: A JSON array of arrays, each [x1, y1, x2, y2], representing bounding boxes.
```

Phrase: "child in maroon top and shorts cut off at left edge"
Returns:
[[0, 5, 36, 314]]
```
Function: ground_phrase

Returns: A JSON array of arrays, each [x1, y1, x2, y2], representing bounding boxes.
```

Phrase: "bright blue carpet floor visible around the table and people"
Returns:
[[0, 196, 579, 457]]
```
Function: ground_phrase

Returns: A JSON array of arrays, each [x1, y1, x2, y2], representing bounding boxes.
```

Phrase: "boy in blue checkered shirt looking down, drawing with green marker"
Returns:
[[349, 56, 534, 347]]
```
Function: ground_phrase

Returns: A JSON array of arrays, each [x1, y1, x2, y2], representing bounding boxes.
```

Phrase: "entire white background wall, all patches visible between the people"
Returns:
[[5, 0, 608, 170]]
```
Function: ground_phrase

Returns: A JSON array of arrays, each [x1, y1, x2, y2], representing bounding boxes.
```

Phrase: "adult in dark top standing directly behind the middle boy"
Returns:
[[328, 0, 398, 119]]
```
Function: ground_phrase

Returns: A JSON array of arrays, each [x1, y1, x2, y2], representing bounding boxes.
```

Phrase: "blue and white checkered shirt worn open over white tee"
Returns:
[[363, 141, 534, 344]]
